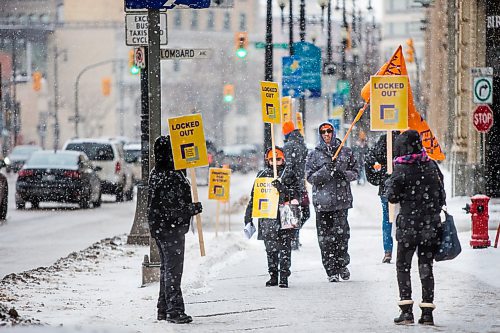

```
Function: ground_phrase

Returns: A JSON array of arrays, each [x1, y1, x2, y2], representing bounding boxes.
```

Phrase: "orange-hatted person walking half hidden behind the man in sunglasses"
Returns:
[[281, 121, 311, 250]]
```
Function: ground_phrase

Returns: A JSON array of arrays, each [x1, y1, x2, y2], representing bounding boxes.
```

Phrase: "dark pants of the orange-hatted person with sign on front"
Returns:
[[264, 229, 294, 278]]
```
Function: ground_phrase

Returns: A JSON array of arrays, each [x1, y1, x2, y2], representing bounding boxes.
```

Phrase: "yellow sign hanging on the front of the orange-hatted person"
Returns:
[[252, 177, 279, 219]]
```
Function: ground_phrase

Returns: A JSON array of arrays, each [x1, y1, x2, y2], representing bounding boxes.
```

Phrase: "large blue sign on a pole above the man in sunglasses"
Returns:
[[293, 42, 322, 98]]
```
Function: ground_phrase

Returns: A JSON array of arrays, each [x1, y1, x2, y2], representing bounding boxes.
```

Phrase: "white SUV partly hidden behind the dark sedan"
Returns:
[[63, 138, 134, 201]]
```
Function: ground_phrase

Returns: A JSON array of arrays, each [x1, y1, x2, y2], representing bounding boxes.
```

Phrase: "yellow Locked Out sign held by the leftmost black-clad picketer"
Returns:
[[168, 114, 208, 170]]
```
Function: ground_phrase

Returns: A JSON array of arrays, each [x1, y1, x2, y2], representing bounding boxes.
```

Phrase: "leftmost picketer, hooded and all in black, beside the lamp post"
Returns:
[[148, 136, 202, 324]]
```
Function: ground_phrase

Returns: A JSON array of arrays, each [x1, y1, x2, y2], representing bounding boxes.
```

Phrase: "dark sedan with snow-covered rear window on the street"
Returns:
[[16, 150, 102, 209]]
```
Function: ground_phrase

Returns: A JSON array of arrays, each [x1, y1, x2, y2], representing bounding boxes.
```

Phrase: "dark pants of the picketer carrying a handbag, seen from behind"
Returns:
[[396, 242, 437, 303]]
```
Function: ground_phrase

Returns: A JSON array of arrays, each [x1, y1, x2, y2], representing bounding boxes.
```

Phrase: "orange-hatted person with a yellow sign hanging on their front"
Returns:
[[245, 147, 300, 288]]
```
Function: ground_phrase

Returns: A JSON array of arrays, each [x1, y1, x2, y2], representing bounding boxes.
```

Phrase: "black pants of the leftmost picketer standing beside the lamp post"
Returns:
[[156, 234, 185, 316]]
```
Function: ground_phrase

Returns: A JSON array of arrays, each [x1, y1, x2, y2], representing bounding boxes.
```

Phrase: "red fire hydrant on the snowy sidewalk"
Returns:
[[464, 194, 491, 249]]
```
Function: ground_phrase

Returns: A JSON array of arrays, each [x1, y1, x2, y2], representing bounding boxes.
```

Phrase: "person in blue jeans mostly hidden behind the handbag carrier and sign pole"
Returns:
[[364, 131, 400, 264]]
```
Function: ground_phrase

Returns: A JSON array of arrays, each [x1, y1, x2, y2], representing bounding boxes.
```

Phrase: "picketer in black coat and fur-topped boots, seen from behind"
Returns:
[[385, 130, 446, 325]]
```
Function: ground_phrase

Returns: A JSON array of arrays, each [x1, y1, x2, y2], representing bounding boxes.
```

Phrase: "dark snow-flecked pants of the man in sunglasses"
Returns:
[[316, 209, 350, 276]]
